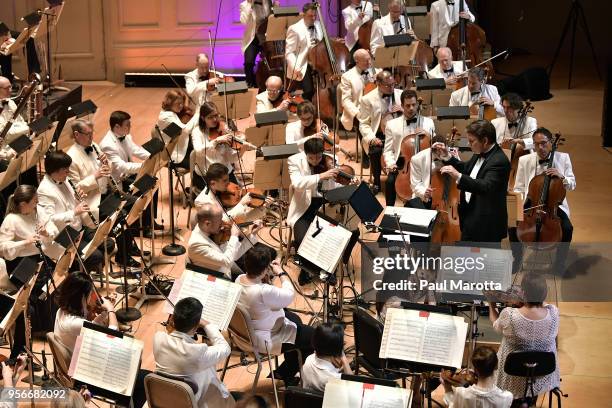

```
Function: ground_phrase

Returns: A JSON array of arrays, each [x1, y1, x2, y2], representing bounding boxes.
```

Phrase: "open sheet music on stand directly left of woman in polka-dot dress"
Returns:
[[379, 308, 468, 368]]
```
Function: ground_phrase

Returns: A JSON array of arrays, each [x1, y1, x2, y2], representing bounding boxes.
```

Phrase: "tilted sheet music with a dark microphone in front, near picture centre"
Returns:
[[298, 216, 352, 273]]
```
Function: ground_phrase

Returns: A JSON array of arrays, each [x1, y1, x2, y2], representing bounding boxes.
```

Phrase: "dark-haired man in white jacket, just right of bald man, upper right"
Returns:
[[449, 67, 504, 117]]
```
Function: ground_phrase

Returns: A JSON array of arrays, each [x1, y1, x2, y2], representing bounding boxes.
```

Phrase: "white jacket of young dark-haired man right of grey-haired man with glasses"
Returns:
[[100, 130, 150, 181]]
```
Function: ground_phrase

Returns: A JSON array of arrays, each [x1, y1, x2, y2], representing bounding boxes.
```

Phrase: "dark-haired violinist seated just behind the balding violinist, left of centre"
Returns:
[[195, 163, 264, 222]]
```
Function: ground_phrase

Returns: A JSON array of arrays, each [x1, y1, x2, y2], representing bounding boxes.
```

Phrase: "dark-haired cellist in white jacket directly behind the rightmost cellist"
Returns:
[[491, 92, 538, 150]]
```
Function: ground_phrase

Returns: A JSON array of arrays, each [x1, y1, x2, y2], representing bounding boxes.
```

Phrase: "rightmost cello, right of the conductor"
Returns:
[[516, 133, 565, 243]]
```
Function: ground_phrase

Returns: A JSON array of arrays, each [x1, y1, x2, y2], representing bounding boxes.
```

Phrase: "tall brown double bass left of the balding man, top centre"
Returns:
[[308, 1, 350, 123]]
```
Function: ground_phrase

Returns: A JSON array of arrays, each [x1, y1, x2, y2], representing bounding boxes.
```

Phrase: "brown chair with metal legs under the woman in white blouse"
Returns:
[[221, 304, 302, 392]]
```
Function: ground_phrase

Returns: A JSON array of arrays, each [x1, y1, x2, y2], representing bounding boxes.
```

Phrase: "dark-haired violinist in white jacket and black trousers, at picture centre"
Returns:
[[287, 138, 340, 285]]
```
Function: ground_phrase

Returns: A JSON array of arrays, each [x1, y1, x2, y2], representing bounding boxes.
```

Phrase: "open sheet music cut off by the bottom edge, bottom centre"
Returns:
[[322, 378, 412, 408]]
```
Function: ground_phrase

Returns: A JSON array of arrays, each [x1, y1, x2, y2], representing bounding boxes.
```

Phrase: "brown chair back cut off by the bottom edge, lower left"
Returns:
[[145, 373, 198, 408]]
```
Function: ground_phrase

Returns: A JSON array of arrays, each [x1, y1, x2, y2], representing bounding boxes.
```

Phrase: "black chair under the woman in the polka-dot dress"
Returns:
[[504, 351, 568, 408]]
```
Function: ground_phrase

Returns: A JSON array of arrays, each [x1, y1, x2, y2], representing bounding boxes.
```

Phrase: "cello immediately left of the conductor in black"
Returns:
[[429, 126, 461, 243]]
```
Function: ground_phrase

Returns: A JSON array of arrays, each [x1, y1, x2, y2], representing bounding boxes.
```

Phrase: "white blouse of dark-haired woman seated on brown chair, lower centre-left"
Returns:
[[236, 275, 297, 354]]
